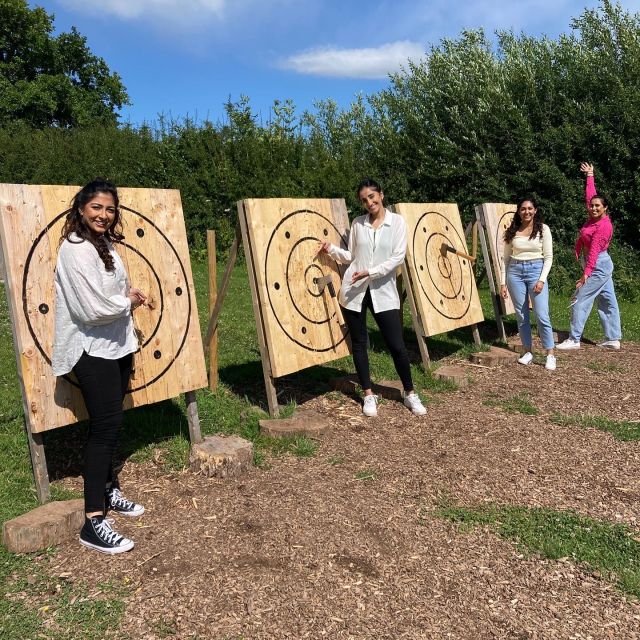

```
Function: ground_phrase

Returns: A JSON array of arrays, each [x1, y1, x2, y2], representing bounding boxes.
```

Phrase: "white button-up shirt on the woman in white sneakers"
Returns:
[[327, 209, 407, 313]]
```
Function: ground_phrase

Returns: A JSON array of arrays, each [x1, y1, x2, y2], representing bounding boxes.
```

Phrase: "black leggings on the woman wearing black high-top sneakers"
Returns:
[[73, 353, 133, 513]]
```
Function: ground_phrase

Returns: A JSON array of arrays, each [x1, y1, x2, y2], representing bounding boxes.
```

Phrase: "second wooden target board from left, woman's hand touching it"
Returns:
[[238, 198, 349, 378]]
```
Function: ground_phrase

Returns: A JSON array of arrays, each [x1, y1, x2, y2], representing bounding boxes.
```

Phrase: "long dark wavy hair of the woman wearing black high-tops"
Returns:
[[60, 178, 124, 271]]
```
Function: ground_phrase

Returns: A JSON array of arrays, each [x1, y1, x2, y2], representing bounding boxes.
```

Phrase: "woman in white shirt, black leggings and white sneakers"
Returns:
[[320, 179, 427, 416]]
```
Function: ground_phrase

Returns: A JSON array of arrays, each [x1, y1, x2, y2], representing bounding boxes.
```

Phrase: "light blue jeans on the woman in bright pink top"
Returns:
[[569, 251, 622, 340]]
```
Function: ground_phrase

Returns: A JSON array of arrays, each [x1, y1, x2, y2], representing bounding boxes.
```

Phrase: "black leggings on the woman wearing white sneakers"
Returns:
[[342, 289, 413, 391]]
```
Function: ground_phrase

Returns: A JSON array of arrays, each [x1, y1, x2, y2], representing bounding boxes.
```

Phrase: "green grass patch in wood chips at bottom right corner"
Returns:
[[436, 506, 640, 598]]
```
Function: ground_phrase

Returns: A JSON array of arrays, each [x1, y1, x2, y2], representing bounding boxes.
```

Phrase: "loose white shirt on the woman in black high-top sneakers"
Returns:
[[51, 234, 138, 376]]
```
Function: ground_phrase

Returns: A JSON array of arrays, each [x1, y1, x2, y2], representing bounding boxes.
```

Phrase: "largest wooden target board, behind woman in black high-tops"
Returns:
[[0, 184, 207, 433]]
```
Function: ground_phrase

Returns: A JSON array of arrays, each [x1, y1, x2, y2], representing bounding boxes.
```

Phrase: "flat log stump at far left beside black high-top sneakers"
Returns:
[[2, 499, 84, 553]]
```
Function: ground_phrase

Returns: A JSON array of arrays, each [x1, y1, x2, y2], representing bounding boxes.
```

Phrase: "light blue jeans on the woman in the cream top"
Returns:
[[507, 259, 554, 349]]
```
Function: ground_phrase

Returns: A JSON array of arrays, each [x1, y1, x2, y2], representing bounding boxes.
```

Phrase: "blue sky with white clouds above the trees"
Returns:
[[37, 0, 640, 124]]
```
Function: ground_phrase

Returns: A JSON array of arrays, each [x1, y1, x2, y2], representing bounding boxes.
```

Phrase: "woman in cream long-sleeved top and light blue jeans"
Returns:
[[500, 198, 556, 371]]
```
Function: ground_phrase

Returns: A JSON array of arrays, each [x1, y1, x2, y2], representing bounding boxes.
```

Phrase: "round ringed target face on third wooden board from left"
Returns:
[[413, 211, 474, 320]]
